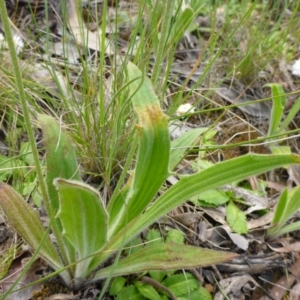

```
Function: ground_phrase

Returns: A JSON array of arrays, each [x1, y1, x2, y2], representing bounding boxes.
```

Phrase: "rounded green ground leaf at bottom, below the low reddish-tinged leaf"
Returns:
[[162, 273, 199, 296]]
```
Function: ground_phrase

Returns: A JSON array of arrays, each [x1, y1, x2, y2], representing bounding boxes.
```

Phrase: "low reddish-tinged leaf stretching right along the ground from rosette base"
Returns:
[[93, 243, 237, 280]]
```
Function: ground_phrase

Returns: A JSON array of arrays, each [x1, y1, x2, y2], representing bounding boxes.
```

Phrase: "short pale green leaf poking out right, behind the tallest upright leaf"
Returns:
[[169, 127, 208, 171]]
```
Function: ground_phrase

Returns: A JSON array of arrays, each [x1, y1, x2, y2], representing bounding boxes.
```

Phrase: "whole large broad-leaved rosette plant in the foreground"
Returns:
[[0, 63, 300, 296]]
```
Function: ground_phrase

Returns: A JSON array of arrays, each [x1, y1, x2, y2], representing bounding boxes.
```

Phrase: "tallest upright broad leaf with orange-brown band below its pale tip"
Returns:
[[108, 63, 170, 236]]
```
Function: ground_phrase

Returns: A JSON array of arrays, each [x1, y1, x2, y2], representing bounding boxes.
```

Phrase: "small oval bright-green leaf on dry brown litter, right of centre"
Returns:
[[226, 200, 248, 234]]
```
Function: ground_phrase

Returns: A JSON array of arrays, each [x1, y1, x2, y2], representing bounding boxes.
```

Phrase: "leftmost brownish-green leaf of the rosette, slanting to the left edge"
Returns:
[[0, 183, 71, 284]]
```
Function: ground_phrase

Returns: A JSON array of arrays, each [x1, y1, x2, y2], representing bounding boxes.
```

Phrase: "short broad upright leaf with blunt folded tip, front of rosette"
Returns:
[[54, 179, 108, 278]]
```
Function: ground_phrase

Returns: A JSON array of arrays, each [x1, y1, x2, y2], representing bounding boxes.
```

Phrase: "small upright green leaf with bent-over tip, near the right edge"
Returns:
[[264, 83, 286, 136]]
